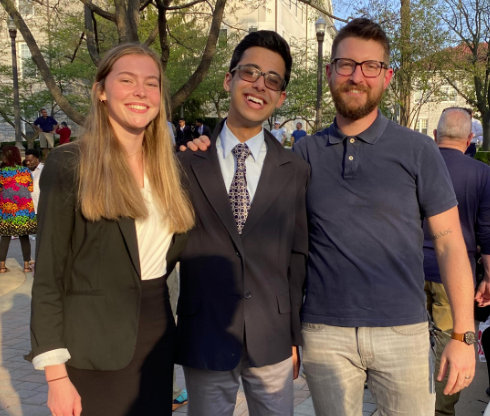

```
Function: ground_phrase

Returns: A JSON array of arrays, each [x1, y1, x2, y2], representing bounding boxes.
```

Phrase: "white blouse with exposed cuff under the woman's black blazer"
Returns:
[[32, 179, 173, 370]]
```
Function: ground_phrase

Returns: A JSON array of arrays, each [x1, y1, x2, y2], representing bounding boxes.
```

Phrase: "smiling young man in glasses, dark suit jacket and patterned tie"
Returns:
[[177, 31, 309, 416]]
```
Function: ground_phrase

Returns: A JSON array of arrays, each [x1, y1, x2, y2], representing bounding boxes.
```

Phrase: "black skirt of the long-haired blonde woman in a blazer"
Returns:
[[67, 277, 176, 416]]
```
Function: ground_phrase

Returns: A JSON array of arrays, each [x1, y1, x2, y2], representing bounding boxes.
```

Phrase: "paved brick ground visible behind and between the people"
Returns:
[[0, 240, 489, 416]]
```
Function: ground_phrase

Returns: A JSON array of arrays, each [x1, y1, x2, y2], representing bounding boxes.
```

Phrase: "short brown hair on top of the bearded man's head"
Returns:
[[331, 17, 390, 64]]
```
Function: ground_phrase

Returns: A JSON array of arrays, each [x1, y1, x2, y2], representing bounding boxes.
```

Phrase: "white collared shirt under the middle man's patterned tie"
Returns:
[[216, 121, 267, 201]]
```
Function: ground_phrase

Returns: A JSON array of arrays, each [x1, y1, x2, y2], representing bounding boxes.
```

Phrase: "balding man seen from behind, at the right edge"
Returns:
[[424, 108, 490, 416]]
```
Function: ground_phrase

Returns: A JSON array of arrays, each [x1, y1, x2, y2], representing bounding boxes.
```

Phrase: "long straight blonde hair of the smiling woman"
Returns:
[[78, 43, 194, 233]]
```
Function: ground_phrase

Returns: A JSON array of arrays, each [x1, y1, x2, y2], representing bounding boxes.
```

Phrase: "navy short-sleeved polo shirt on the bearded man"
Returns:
[[294, 112, 457, 327]]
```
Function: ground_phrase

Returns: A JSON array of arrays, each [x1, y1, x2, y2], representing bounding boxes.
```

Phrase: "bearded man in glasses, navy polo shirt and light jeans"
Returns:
[[294, 19, 475, 416]]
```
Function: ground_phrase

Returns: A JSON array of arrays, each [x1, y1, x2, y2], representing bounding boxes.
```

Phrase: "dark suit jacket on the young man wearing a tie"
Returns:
[[176, 119, 309, 371]]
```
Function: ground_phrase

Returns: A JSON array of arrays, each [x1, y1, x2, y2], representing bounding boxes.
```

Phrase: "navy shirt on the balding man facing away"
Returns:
[[424, 147, 490, 283]]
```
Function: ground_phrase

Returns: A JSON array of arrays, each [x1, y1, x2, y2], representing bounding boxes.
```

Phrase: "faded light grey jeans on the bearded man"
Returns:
[[303, 322, 435, 416]]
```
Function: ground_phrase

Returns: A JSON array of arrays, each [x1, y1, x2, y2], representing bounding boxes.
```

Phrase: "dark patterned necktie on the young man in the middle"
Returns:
[[229, 143, 252, 234]]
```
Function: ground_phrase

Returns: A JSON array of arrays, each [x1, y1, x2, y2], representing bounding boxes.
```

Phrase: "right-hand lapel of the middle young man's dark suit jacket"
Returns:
[[242, 131, 293, 238]]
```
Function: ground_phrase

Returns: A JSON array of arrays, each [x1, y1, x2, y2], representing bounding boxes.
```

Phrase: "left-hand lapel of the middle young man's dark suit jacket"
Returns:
[[191, 120, 242, 248]]
